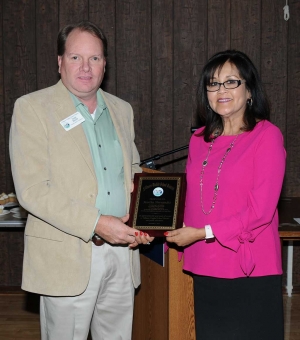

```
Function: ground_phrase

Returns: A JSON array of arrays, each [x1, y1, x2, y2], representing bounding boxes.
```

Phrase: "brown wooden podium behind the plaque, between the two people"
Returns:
[[132, 169, 196, 340]]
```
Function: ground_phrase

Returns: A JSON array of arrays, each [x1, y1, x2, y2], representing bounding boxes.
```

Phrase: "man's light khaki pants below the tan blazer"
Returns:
[[40, 243, 134, 340]]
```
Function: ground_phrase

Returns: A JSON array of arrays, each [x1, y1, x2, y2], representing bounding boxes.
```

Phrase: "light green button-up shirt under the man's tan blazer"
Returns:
[[71, 91, 126, 220]]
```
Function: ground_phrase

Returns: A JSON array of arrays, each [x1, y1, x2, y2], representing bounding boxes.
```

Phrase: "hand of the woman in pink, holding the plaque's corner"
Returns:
[[165, 224, 205, 247]]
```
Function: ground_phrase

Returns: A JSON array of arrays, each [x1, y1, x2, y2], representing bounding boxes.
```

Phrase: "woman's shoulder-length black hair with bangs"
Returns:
[[197, 50, 270, 142]]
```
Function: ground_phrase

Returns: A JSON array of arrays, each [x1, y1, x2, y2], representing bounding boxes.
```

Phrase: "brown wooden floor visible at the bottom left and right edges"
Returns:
[[0, 293, 300, 340]]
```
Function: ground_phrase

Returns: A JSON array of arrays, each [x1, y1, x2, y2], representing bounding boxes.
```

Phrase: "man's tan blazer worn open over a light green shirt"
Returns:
[[9, 81, 141, 296]]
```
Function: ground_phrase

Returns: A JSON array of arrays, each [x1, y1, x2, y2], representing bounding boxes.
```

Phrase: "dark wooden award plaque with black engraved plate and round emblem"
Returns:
[[128, 173, 186, 237]]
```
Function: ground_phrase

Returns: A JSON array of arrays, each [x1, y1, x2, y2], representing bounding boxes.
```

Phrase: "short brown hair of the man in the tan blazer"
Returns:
[[57, 20, 107, 58]]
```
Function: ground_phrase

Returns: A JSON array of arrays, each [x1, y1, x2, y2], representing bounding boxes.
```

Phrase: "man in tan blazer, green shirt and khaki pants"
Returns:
[[10, 21, 152, 340]]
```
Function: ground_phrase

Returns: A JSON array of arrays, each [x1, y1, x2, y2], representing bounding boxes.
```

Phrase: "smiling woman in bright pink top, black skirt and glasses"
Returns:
[[166, 50, 286, 340]]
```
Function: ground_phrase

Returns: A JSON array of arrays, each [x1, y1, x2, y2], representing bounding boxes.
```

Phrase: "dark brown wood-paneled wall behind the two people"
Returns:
[[0, 0, 300, 196]]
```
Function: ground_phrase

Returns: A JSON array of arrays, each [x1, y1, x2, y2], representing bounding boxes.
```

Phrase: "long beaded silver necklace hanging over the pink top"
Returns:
[[200, 134, 239, 215]]
